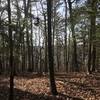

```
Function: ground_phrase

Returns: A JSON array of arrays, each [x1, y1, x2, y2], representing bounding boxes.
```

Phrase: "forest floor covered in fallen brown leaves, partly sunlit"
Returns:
[[0, 73, 100, 100]]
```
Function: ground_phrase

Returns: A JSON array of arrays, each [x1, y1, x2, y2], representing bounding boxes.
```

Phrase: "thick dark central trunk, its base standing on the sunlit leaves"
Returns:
[[47, 0, 58, 95]]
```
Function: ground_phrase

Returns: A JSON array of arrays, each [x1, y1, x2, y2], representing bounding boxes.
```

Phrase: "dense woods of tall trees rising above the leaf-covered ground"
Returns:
[[0, 0, 100, 100]]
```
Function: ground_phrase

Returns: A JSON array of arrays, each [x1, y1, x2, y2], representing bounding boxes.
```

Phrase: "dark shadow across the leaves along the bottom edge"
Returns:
[[0, 86, 83, 100]]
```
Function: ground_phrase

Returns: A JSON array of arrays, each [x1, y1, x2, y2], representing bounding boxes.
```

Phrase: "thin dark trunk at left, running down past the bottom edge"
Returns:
[[7, 0, 14, 100]]
